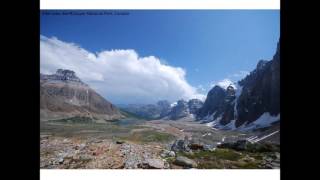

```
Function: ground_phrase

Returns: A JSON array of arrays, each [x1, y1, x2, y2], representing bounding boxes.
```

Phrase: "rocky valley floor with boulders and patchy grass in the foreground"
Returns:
[[40, 118, 280, 169]]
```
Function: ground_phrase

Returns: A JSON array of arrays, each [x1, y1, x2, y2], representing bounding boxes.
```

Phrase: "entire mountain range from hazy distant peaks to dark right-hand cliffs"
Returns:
[[125, 40, 280, 131]]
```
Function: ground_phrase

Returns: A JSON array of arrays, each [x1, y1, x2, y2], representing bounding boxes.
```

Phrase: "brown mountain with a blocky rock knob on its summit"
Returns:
[[40, 69, 122, 121]]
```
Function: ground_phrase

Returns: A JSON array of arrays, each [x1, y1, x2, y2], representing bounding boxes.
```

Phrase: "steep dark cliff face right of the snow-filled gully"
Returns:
[[236, 42, 280, 126]]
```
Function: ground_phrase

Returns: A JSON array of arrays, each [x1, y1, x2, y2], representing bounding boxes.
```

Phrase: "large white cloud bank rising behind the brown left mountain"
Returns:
[[40, 36, 205, 103]]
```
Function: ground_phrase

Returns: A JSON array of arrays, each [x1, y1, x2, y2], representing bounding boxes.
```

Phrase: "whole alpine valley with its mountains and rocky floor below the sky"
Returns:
[[40, 43, 280, 169]]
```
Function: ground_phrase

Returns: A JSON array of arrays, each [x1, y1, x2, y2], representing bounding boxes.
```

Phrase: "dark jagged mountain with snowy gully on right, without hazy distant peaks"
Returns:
[[197, 40, 280, 130]]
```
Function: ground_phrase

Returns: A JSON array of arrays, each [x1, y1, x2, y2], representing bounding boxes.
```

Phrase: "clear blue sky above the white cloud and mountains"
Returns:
[[40, 10, 280, 104]]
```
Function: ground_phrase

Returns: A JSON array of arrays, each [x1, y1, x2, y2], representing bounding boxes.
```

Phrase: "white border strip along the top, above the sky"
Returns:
[[40, 0, 280, 9]]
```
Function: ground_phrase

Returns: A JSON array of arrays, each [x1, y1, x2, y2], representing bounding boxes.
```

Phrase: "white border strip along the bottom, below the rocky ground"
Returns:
[[40, 169, 280, 180]]
